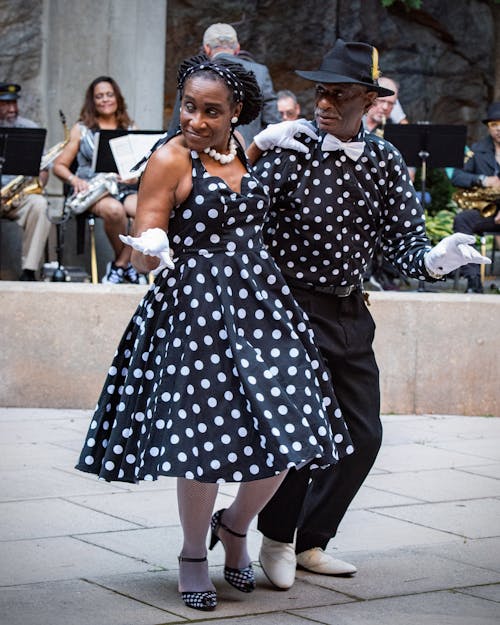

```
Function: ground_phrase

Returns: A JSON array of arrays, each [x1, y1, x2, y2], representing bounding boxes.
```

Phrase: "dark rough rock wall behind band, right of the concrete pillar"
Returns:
[[165, 0, 500, 142]]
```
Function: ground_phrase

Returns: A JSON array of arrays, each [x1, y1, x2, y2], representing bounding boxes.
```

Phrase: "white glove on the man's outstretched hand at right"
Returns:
[[424, 232, 491, 278]]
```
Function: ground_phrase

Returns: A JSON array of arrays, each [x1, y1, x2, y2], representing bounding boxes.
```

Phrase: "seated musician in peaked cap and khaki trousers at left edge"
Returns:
[[0, 82, 51, 281]]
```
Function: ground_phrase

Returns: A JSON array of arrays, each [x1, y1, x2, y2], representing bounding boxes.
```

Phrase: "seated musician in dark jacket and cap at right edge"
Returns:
[[451, 102, 500, 293]]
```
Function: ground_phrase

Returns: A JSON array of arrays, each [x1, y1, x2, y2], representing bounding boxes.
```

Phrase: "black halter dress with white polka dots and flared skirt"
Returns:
[[77, 147, 353, 482]]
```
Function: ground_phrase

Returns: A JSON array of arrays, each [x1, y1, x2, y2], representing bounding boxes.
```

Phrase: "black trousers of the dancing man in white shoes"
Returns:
[[258, 287, 382, 553]]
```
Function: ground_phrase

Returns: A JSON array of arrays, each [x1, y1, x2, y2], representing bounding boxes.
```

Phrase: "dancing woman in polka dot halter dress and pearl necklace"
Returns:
[[77, 57, 352, 610]]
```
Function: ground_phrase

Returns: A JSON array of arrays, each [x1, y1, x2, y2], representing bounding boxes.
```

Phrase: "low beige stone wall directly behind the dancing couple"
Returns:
[[0, 282, 500, 416]]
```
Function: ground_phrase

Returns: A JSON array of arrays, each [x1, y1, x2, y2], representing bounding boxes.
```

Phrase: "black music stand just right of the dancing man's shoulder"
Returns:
[[384, 123, 467, 208]]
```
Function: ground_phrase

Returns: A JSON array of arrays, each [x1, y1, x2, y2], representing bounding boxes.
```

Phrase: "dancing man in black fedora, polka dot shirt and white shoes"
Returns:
[[248, 39, 488, 589]]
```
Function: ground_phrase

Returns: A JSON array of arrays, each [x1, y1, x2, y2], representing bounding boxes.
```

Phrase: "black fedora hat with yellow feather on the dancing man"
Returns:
[[295, 39, 394, 96]]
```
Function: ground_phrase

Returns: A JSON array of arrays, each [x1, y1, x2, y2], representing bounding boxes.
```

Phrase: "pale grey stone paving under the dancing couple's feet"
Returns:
[[0, 408, 500, 625]]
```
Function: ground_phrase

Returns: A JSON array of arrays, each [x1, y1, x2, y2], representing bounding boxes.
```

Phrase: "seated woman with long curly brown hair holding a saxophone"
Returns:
[[54, 76, 147, 284]]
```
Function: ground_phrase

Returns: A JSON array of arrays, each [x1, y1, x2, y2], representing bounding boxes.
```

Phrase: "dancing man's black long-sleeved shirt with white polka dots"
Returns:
[[255, 127, 432, 286]]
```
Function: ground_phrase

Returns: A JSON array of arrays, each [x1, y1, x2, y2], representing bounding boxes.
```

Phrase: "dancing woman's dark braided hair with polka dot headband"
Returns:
[[177, 54, 262, 125]]
